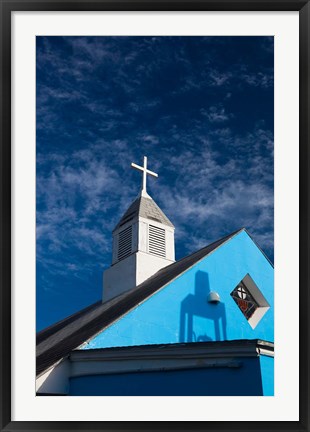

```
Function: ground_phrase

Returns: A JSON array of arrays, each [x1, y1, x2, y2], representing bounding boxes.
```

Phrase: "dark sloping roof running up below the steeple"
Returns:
[[36, 228, 244, 375]]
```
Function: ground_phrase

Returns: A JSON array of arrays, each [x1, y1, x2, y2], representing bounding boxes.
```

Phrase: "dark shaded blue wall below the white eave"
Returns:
[[69, 357, 263, 396]]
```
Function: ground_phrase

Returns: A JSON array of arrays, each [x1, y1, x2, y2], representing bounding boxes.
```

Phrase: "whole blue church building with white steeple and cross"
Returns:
[[36, 157, 274, 396]]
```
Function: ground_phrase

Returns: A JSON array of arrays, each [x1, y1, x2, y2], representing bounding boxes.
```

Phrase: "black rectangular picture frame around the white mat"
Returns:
[[0, 0, 310, 431]]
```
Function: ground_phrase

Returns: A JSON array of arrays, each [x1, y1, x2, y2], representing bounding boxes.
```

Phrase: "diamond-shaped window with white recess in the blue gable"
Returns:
[[230, 274, 270, 329]]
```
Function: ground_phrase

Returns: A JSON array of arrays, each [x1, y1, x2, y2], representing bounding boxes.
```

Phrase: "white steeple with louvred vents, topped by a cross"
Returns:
[[102, 156, 175, 302]]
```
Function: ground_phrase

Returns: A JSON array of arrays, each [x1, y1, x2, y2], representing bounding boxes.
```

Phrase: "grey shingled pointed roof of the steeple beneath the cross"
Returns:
[[114, 194, 174, 231]]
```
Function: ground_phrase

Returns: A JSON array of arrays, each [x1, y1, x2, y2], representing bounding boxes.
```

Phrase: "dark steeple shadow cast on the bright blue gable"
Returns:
[[180, 270, 227, 342]]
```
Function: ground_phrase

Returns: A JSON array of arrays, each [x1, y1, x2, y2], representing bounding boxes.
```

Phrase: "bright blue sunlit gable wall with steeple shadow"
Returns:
[[82, 231, 274, 349]]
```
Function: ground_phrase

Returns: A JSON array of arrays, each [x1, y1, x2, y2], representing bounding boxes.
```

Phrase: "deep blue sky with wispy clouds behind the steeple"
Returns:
[[36, 36, 274, 330]]
